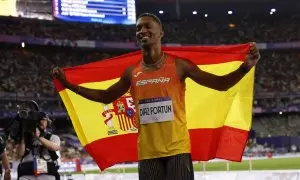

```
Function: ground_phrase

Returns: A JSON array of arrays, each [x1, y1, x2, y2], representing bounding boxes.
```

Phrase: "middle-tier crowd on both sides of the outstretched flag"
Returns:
[[0, 47, 300, 112]]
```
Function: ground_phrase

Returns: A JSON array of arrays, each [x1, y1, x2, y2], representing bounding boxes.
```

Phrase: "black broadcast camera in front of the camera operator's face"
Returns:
[[6, 100, 50, 142]]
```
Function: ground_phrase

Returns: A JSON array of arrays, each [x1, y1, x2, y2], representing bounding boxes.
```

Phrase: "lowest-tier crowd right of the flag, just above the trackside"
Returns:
[[244, 113, 300, 156]]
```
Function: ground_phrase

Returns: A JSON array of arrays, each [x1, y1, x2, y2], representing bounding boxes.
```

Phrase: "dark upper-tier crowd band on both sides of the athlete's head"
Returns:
[[0, 14, 300, 44]]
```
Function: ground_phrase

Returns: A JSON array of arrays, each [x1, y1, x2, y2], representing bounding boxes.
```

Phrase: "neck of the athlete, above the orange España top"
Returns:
[[142, 46, 162, 65]]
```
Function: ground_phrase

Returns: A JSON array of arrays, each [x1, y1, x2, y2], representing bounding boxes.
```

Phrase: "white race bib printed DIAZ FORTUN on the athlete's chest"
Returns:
[[139, 97, 174, 124]]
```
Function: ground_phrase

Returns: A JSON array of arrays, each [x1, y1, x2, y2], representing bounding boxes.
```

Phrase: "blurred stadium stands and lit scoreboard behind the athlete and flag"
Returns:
[[0, 0, 300, 177]]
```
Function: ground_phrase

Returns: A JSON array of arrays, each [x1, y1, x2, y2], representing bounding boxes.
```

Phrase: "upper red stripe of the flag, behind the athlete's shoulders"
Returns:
[[54, 44, 250, 92]]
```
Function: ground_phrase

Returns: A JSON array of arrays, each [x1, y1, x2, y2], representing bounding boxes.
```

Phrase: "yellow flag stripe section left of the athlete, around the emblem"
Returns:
[[60, 78, 135, 146]]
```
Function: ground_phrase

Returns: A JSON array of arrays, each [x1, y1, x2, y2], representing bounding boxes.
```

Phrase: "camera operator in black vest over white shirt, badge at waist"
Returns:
[[17, 112, 60, 180]]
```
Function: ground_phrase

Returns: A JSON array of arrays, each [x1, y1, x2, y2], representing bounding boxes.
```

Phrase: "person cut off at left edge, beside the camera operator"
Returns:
[[0, 135, 11, 180]]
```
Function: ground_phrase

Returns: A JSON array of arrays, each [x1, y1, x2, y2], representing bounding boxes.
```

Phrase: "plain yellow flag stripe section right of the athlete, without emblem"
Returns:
[[186, 61, 254, 131]]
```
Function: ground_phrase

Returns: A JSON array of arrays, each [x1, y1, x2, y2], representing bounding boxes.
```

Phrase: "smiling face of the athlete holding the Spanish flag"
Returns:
[[136, 16, 163, 47]]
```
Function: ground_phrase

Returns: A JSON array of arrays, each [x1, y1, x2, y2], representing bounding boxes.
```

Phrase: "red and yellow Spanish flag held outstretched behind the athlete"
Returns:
[[54, 44, 254, 170]]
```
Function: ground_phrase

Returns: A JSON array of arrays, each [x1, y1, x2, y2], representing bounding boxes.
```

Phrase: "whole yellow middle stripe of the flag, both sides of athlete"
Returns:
[[60, 61, 254, 146]]
